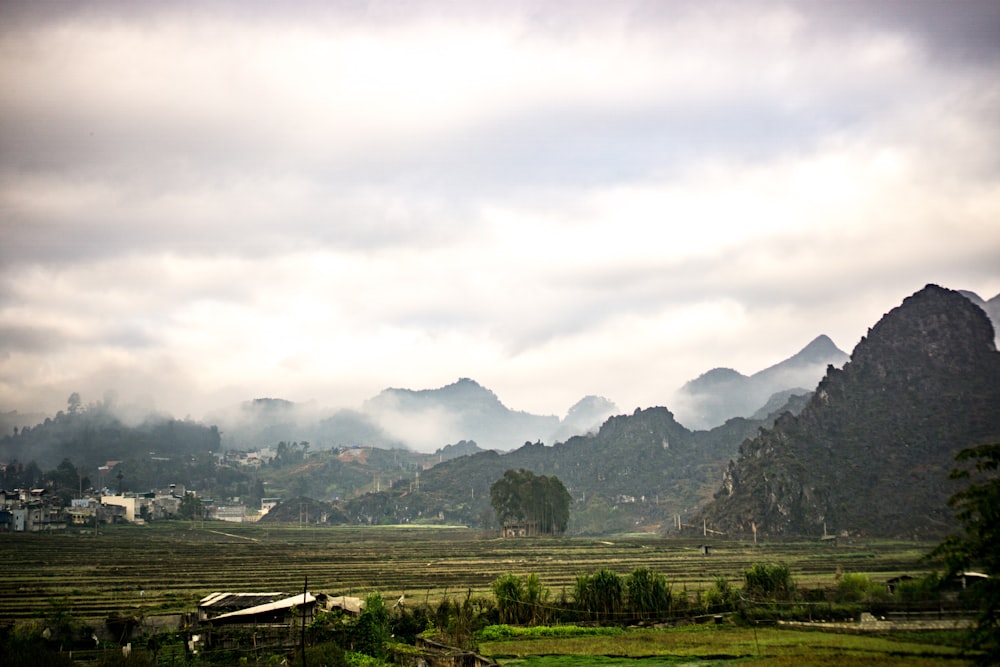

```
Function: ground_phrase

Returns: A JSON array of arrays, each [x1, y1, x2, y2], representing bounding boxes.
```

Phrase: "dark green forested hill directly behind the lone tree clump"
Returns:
[[410, 396, 808, 532]]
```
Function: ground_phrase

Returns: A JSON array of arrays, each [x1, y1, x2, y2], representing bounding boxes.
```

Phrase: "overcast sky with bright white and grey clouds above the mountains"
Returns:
[[0, 0, 1000, 426]]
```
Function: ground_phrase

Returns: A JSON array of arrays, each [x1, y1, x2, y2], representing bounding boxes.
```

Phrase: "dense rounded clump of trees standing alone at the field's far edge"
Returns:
[[490, 469, 572, 534]]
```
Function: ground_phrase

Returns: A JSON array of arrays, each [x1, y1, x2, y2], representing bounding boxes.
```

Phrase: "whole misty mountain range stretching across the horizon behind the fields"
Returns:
[[0, 285, 1000, 536]]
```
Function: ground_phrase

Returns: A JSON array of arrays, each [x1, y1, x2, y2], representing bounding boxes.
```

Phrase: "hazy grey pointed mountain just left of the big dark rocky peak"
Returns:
[[675, 336, 847, 428]]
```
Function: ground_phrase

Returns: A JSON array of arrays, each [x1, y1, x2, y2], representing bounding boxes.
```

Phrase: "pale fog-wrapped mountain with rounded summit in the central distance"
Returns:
[[362, 378, 559, 450]]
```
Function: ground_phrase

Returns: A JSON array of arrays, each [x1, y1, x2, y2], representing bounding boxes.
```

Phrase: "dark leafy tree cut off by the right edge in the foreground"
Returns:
[[931, 443, 1000, 665]]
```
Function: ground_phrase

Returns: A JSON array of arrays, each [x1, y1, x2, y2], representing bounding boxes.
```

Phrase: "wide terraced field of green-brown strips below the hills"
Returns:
[[0, 522, 932, 623]]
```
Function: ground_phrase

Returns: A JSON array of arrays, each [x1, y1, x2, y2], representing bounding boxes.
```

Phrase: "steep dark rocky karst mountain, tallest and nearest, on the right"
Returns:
[[704, 285, 1000, 537]]
